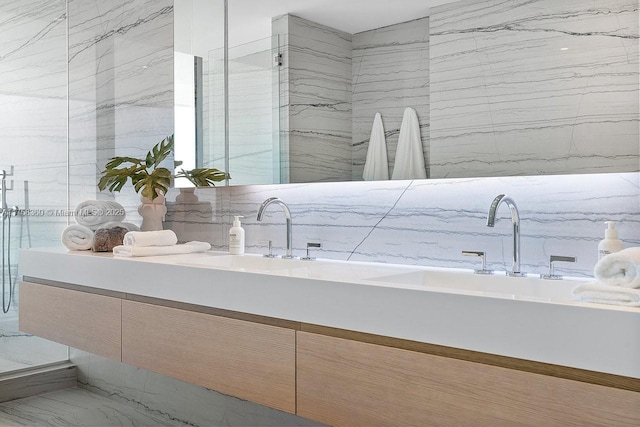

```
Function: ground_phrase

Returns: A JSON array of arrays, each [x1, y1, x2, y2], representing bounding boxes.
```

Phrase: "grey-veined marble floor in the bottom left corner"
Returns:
[[0, 388, 193, 427]]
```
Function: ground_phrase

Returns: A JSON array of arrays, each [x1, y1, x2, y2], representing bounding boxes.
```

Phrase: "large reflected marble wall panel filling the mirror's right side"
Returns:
[[430, 0, 640, 178]]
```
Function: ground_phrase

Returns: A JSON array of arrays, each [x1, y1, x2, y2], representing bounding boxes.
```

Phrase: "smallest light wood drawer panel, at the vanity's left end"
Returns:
[[19, 282, 122, 361]]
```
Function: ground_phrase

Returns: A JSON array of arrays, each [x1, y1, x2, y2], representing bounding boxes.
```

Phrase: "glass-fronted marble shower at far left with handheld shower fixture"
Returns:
[[0, 0, 69, 380]]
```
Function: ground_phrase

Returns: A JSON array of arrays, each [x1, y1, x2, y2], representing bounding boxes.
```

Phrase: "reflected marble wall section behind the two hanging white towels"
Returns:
[[352, 17, 429, 181]]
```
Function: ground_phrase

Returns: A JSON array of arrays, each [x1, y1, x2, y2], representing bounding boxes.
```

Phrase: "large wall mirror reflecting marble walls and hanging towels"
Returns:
[[174, 0, 640, 185]]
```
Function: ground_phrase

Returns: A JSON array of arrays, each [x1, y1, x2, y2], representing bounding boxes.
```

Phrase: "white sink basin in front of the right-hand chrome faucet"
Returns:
[[372, 269, 580, 301]]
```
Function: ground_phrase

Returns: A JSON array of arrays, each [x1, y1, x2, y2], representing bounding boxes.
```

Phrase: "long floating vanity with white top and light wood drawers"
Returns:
[[20, 249, 640, 425]]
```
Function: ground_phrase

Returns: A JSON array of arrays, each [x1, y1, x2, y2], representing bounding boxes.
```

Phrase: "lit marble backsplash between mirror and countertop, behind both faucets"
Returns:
[[165, 172, 640, 277]]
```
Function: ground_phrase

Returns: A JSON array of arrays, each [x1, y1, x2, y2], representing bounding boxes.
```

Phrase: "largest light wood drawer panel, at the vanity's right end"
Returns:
[[297, 332, 640, 427]]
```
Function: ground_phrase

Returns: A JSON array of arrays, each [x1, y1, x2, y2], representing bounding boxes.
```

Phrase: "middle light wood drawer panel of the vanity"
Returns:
[[122, 301, 295, 413]]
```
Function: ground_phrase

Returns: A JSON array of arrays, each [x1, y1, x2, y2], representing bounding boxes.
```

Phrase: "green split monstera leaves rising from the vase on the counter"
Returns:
[[98, 135, 231, 201]]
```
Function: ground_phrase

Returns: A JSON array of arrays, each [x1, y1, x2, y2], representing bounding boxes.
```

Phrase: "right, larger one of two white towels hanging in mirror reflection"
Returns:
[[391, 108, 427, 179]]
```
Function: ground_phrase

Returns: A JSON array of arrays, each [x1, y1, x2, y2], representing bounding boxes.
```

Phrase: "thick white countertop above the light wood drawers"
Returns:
[[20, 248, 640, 378]]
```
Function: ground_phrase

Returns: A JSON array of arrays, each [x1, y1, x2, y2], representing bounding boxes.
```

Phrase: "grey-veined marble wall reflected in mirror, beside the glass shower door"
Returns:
[[272, 15, 351, 182]]
